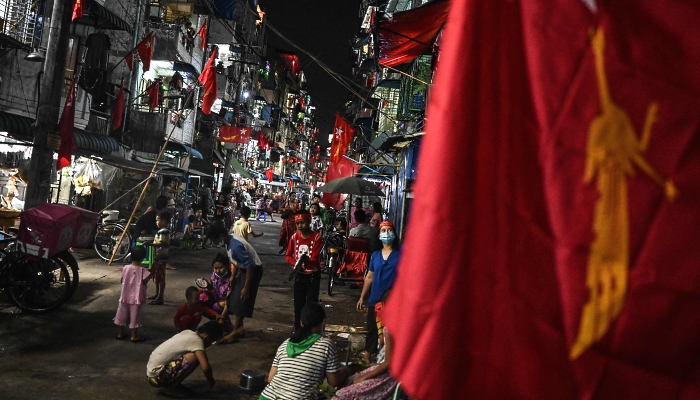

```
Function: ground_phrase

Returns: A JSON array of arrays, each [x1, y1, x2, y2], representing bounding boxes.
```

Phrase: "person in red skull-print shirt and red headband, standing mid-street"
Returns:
[[285, 210, 323, 331]]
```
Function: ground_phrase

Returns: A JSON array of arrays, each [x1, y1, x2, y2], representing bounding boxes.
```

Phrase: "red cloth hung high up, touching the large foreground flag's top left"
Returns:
[[377, 0, 450, 67]]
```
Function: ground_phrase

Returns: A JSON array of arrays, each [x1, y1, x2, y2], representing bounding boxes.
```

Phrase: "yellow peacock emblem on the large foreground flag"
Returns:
[[569, 28, 678, 359]]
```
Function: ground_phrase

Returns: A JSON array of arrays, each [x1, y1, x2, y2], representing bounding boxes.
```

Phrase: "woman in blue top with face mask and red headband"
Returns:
[[357, 220, 400, 361]]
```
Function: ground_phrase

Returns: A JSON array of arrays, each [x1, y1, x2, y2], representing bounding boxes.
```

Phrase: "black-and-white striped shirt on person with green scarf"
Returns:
[[262, 338, 340, 400]]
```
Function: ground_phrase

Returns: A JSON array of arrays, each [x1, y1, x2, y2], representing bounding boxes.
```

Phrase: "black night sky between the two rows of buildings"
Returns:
[[259, 0, 361, 143]]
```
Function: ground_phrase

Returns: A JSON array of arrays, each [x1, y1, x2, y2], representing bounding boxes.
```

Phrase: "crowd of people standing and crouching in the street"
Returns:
[[114, 180, 400, 400]]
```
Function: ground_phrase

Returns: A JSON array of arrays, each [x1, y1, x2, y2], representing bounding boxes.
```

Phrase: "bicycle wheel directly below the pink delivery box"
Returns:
[[7, 257, 71, 313]]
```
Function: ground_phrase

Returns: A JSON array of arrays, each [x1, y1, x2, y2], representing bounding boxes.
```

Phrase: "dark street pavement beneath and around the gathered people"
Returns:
[[0, 219, 365, 400]]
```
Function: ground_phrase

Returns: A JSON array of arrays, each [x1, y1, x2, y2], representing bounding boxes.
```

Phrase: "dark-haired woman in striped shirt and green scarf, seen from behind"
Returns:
[[260, 303, 349, 400]]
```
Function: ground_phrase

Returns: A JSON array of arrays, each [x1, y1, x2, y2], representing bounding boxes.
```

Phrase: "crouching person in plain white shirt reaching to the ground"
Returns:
[[146, 321, 223, 397]]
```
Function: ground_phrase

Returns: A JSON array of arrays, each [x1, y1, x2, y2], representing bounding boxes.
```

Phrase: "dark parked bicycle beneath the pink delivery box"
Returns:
[[0, 233, 77, 313]]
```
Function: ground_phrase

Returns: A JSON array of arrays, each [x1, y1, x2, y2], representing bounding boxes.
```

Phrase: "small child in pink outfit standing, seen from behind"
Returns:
[[114, 246, 151, 343]]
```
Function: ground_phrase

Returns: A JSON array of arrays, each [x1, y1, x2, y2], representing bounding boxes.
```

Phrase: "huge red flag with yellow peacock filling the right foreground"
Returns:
[[384, 0, 700, 399]]
